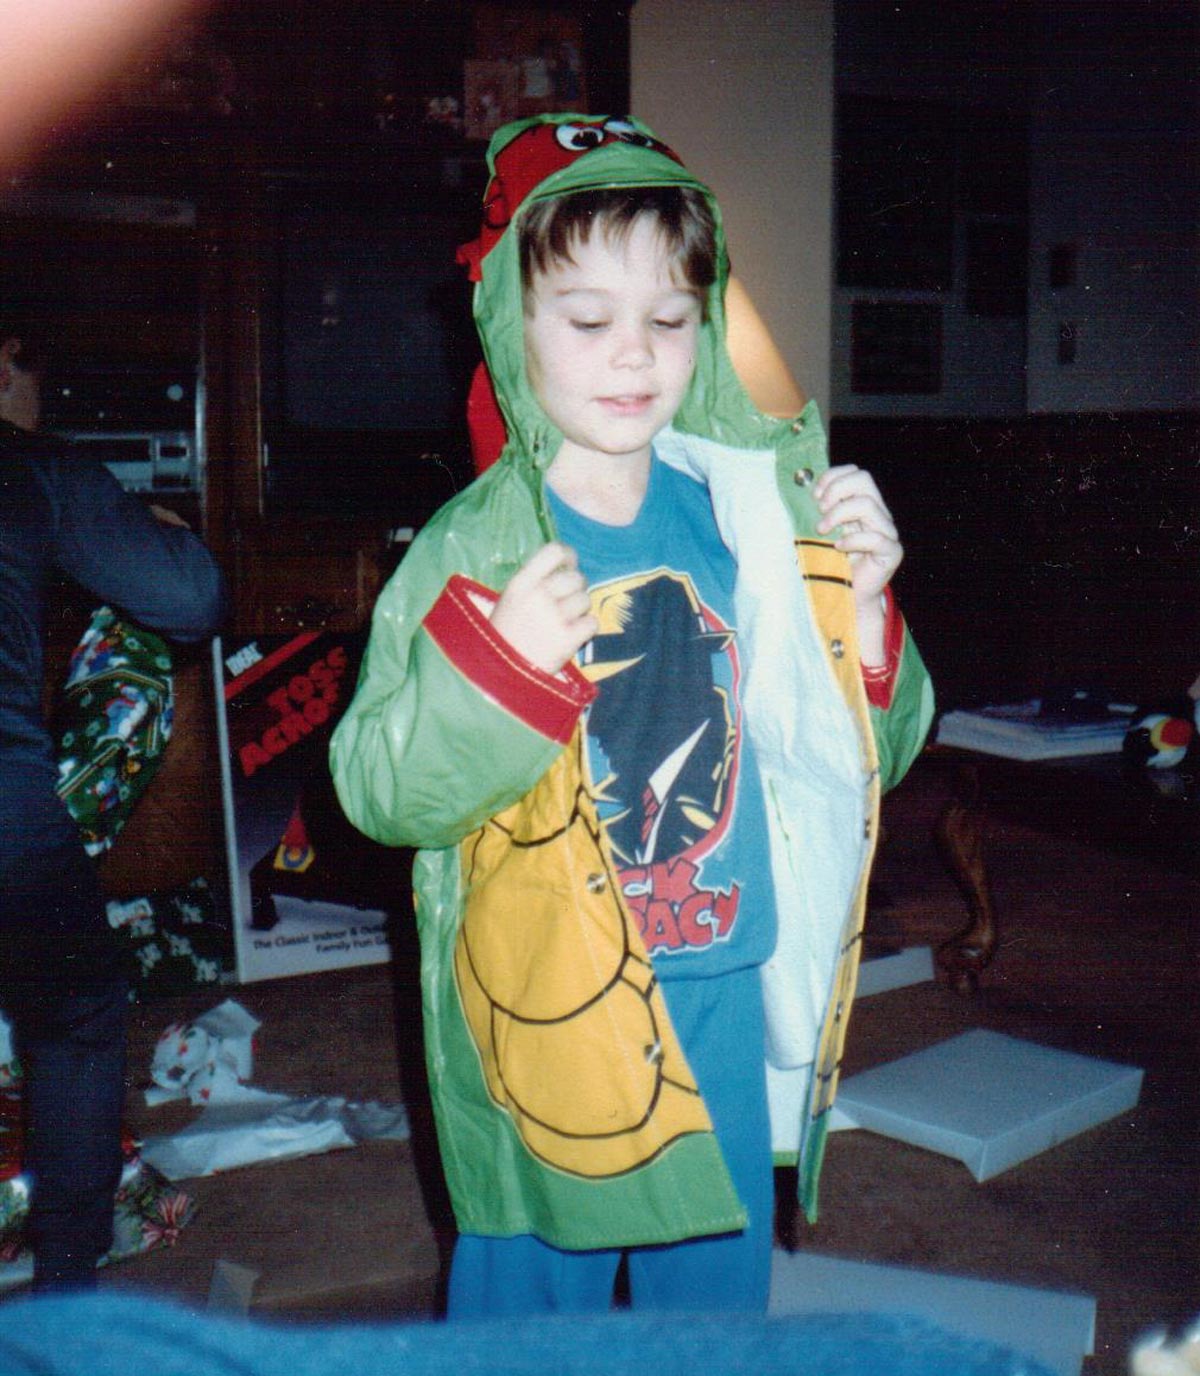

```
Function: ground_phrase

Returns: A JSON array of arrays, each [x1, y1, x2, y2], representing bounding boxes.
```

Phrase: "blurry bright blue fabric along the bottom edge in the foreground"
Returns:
[[0, 1293, 1050, 1376]]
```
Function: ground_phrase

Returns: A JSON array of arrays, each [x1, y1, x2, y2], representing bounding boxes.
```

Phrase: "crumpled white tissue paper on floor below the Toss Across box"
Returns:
[[142, 999, 409, 1181]]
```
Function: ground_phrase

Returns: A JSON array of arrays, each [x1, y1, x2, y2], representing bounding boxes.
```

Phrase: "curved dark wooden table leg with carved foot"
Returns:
[[934, 764, 998, 993]]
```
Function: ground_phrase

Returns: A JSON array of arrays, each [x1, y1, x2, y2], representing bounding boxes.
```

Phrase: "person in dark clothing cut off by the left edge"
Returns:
[[0, 316, 226, 1291]]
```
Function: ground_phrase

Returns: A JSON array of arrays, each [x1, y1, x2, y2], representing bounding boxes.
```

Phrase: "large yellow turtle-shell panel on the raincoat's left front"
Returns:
[[454, 747, 710, 1176]]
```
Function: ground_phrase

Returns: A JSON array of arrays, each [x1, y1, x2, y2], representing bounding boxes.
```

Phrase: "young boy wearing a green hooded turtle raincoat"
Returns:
[[332, 116, 932, 1315]]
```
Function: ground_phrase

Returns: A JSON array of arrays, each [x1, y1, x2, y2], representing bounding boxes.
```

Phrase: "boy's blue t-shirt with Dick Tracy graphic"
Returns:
[[548, 460, 775, 978]]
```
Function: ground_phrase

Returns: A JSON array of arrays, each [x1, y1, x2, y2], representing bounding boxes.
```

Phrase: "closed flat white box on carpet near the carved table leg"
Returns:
[[837, 1029, 1142, 1181]]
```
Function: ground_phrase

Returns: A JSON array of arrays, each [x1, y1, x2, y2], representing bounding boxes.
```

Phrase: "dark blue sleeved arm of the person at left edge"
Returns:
[[43, 455, 226, 643]]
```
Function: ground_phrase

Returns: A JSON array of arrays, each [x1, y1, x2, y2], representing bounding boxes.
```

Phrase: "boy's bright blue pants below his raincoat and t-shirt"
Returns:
[[447, 969, 775, 1318]]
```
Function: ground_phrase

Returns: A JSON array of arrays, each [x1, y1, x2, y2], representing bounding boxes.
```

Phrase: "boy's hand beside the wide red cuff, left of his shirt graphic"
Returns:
[[491, 542, 600, 674]]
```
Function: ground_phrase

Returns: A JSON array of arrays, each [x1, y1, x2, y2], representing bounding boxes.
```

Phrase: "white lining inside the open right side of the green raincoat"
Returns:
[[655, 431, 868, 1117]]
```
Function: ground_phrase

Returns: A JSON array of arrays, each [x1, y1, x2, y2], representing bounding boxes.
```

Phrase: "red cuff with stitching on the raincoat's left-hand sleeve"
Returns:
[[424, 574, 596, 746]]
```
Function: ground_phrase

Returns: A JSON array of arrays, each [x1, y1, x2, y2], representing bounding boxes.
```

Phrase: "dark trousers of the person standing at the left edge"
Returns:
[[0, 845, 128, 1291]]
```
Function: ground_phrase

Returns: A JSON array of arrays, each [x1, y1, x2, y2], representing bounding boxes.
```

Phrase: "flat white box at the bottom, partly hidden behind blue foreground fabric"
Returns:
[[771, 1248, 1095, 1376]]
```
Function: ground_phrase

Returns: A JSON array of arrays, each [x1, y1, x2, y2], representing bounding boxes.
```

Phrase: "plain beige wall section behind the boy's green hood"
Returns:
[[632, 0, 834, 414]]
